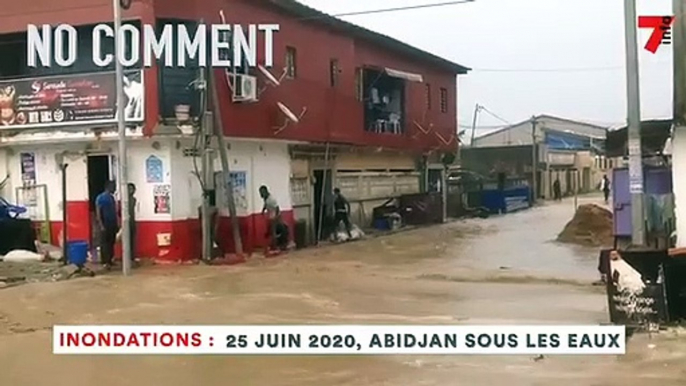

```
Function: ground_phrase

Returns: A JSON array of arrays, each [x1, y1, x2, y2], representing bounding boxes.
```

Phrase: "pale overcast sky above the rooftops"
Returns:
[[300, 0, 672, 135]]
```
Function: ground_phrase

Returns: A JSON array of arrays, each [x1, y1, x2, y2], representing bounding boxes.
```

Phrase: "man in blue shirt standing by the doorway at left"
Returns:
[[95, 181, 119, 268]]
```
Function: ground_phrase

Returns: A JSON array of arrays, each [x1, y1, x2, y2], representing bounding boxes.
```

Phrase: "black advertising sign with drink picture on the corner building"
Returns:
[[0, 70, 144, 129]]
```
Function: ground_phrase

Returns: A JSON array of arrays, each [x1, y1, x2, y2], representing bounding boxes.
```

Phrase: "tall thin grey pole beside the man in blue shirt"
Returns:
[[113, 0, 131, 276]]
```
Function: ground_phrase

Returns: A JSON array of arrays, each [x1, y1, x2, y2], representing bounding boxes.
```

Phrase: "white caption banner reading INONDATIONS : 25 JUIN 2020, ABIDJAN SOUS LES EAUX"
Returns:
[[53, 325, 626, 355]]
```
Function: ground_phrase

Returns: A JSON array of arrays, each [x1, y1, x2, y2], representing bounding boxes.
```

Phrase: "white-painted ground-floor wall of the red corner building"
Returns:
[[0, 139, 292, 225]]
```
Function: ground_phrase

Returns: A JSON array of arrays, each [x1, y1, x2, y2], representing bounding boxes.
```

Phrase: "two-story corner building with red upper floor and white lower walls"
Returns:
[[0, 0, 469, 261]]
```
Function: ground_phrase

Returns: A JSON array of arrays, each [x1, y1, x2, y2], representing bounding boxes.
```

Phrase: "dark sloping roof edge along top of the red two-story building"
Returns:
[[264, 0, 471, 74]]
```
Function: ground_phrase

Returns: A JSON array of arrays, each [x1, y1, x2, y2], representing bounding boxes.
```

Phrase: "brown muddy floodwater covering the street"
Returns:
[[0, 198, 686, 386]]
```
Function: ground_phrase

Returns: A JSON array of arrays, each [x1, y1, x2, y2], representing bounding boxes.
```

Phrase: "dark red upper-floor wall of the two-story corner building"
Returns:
[[0, 0, 468, 151]]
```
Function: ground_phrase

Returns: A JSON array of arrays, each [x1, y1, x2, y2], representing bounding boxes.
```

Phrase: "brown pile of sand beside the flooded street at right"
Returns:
[[557, 204, 614, 246]]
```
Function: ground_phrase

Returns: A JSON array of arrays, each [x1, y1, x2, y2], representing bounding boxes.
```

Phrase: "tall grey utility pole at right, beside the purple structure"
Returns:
[[624, 0, 645, 246]]
